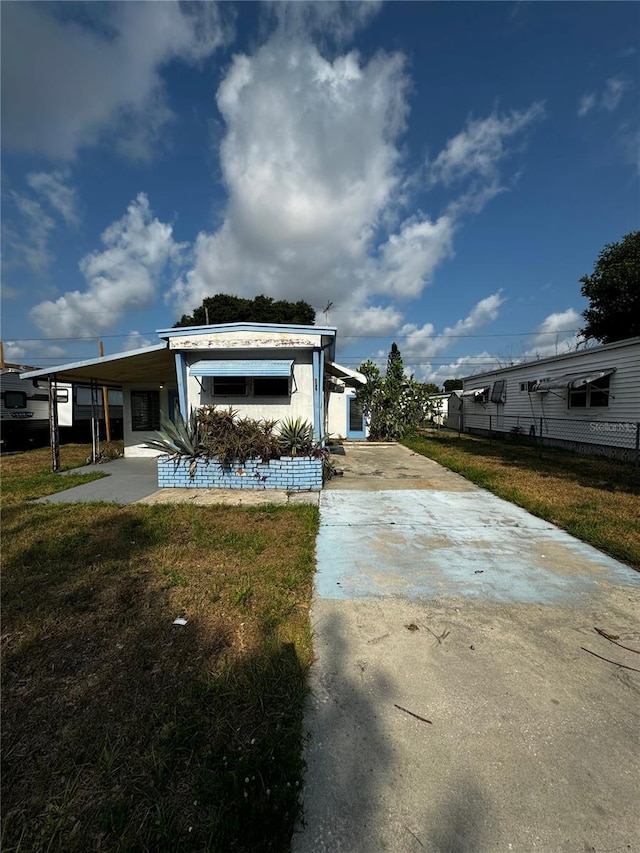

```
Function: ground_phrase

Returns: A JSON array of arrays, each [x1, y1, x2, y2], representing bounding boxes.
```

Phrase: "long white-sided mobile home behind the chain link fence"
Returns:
[[461, 338, 640, 458]]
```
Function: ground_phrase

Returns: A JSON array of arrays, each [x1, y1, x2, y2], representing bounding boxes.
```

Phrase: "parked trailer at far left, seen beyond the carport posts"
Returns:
[[0, 368, 73, 450]]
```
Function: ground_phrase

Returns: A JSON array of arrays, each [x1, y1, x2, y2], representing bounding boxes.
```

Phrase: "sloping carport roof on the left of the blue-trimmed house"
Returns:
[[21, 343, 176, 385]]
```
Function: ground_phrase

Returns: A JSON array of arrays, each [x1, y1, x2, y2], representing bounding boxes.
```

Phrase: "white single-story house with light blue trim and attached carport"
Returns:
[[23, 323, 366, 457]]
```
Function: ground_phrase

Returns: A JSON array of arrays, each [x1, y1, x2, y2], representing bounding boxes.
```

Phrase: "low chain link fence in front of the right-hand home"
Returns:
[[438, 412, 640, 471]]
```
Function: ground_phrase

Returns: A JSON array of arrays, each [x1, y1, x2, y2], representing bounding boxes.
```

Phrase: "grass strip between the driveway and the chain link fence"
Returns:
[[403, 431, 640, 569]]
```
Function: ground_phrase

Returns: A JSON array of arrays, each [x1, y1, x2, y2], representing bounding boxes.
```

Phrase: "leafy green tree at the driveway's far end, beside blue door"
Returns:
[[356, 343, 432, 441]]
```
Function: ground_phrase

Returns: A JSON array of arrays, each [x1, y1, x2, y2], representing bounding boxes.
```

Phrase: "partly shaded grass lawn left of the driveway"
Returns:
[[2, 447, 318, 853]]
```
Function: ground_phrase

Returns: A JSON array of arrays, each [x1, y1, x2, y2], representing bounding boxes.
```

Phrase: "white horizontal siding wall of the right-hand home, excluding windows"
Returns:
[[464, 338, 640, 445]]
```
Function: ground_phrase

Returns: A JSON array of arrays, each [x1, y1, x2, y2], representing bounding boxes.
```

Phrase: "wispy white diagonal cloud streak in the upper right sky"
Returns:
[[429, 103, 544, 186]]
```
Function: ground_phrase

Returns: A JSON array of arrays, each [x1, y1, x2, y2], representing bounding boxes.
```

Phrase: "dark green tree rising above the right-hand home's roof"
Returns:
[[580, 231, 640, 344]]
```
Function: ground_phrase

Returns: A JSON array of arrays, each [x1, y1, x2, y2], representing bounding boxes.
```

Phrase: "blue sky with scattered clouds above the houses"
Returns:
[[1, 2, 640, 382]]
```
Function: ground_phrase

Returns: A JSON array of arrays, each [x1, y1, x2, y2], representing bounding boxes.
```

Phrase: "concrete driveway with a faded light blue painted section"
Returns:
[[293, 445, 640, 853]]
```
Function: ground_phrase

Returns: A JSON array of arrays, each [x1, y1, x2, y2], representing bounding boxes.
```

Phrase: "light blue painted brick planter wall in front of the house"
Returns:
[[158, 456, 322, 492]]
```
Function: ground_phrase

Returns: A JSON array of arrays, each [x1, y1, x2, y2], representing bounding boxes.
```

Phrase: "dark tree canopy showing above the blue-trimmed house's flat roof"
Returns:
[[174, 293, 316, 328]]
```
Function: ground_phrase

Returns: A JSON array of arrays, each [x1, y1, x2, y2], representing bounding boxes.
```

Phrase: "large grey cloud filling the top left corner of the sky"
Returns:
[[2, 2, 228, 159]]
